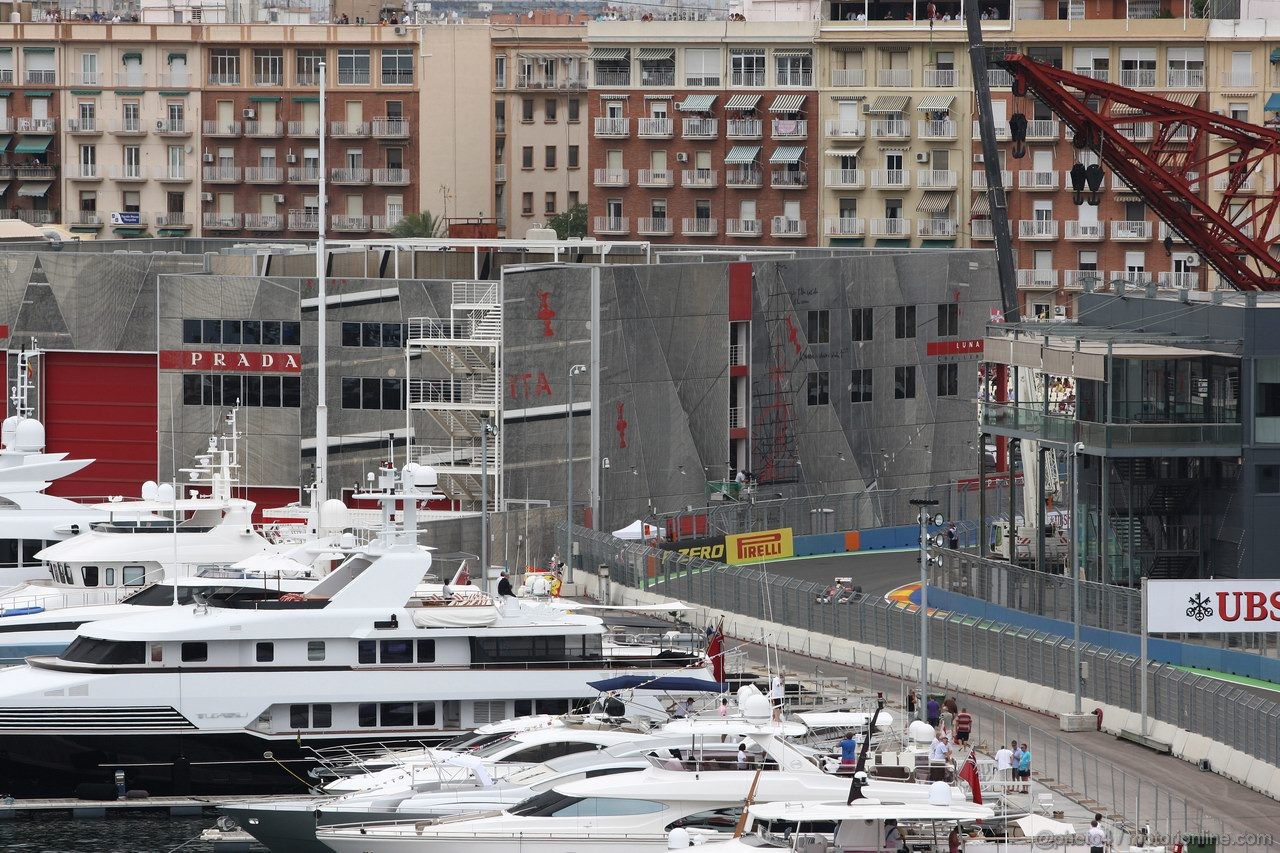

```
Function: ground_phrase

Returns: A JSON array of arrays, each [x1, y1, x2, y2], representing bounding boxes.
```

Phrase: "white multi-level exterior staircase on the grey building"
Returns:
[[404, 282, 503, 512]]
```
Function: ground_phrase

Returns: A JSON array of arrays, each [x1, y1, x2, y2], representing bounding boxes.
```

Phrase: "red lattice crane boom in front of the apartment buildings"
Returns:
[[1000, 54, 1280, 291]]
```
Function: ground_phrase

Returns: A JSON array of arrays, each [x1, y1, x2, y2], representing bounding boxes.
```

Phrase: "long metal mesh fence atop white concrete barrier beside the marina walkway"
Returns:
[[561, 517, 1280, 765]]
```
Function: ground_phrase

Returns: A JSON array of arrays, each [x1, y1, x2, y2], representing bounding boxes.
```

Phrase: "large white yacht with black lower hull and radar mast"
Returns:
[[0, 464, 712, 797]]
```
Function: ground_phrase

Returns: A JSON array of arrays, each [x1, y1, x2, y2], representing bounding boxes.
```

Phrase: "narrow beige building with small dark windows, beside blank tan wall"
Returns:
[[492, 24, 591, 237]]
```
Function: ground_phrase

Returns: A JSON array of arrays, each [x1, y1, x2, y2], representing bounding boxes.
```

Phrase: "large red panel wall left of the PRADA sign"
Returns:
[[38, 352, 157, 497]]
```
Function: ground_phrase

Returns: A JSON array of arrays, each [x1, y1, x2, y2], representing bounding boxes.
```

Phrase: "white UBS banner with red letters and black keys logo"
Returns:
[[1147, 580, 1280, 634]]
